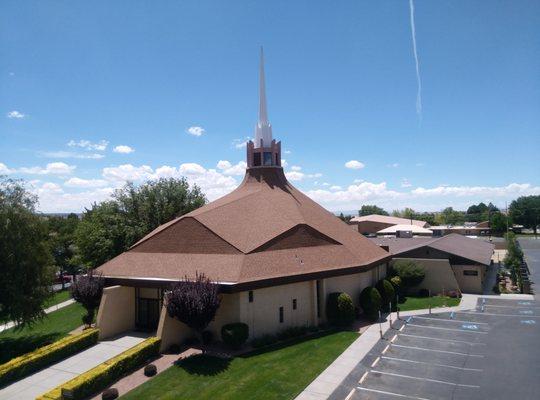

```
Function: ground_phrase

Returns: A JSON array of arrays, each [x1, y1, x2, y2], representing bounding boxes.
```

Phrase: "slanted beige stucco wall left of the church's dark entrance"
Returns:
[[96, 286, 135, 339]]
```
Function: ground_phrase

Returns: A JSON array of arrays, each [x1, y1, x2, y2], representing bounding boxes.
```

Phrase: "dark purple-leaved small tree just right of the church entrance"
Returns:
[[166, 274, 221, 341]]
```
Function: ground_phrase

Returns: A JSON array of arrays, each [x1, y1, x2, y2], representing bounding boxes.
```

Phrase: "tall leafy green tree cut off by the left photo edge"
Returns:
[[0, 177, 53, 325]]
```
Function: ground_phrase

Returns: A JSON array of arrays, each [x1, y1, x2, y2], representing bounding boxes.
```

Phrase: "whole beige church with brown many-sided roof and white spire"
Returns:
[[98, 54, 391, 348]]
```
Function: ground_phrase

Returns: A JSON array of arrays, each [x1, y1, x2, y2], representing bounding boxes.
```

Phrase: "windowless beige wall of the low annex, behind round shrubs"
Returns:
[[392, 258, 463, 295]]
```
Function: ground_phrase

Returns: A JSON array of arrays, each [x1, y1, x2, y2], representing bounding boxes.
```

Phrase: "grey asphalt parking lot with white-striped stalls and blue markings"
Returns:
[[330, 298, 540, 400]]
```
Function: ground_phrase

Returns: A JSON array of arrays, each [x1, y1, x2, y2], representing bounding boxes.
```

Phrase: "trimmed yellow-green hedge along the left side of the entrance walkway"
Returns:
[[0, 329, 99, 386]]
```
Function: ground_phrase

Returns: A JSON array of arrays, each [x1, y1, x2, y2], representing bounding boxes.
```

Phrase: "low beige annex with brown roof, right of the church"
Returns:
[[370, 234, 494, 294]]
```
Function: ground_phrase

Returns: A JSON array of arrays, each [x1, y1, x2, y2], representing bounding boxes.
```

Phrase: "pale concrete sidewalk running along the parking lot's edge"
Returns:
[[296, 294, 480, 400]]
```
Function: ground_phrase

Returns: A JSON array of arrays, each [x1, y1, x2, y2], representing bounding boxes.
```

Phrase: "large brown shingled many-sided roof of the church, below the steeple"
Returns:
[[98, 167, 389, 290]]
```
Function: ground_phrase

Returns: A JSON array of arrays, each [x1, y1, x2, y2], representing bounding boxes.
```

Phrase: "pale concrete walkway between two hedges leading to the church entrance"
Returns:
[[0, 332, 147, 400]]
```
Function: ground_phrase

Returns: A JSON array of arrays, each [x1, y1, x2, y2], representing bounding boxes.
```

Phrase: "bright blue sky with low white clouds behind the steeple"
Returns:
[[0, 0, 540, 212]]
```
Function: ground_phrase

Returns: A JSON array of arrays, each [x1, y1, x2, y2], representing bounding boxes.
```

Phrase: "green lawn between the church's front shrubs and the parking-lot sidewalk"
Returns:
[[122, 332, 358, 400]]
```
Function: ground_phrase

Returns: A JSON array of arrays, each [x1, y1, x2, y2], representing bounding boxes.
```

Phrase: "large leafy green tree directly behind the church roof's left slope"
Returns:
[[75, 178, 206, 268]]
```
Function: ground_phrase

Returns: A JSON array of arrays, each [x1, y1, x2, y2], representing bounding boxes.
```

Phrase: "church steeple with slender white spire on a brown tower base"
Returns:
[[247, 46, 281, 168]]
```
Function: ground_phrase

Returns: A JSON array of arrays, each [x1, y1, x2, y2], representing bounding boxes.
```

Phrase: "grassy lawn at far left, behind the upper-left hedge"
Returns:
[[0, 303, 85, 364]]
